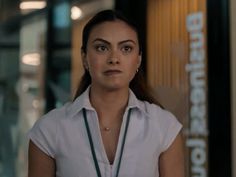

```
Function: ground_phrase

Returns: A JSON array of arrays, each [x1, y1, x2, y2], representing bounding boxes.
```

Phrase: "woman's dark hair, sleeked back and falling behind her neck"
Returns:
[[74, 10, 162, 107]]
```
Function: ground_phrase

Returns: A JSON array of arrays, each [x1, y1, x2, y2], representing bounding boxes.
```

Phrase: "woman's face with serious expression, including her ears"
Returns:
[[82, 20, 141, 90]]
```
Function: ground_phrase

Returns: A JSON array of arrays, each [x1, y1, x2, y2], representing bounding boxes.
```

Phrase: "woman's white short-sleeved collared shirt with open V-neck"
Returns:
[[28, 88, 182, 177]]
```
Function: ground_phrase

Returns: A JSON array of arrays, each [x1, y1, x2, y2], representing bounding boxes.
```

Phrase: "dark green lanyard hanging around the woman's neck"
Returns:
[[83, 108, 131, 177]]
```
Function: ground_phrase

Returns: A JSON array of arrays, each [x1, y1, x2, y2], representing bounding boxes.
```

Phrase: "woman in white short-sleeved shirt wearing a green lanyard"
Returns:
[[29, 10, 184, 177]]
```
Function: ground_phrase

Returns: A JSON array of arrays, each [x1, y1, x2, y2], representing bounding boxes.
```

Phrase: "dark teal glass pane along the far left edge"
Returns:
[[0, 23, 19, 177]]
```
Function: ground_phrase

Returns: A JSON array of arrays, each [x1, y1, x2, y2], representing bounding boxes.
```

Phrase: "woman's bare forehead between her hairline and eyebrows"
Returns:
[[89, 20, 138, 41]]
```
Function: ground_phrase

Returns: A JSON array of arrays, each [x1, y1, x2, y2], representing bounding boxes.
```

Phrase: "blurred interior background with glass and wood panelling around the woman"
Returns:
[[0, 0, 236, 177]]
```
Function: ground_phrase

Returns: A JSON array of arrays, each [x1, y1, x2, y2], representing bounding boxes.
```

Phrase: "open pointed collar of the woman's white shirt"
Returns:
[[68, 86, 147, 116]]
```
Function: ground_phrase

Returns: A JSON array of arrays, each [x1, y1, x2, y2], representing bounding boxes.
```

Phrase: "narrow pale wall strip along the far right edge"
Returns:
[[230, 0, 236, 177]]
